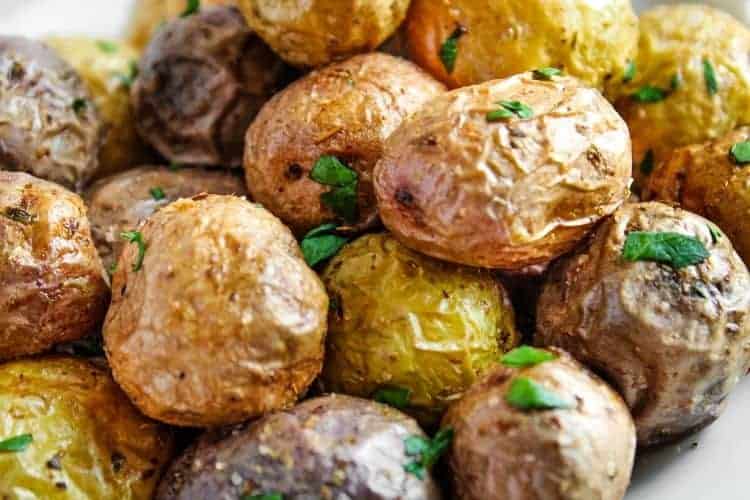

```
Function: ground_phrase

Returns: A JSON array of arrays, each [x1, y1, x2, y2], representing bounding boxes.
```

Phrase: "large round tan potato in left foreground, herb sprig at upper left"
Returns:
[[103, 195, 328, 427]]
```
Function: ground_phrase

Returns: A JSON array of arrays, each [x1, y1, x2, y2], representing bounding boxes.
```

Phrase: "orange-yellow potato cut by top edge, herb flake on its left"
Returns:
[[406, 0, 638, 94]]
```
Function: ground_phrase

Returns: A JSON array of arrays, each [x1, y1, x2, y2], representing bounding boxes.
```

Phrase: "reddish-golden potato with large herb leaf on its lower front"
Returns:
[[245, 53, 445, 234]]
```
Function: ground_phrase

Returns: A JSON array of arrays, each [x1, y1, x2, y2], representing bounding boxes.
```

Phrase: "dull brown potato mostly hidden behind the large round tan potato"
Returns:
[[85, 166, 245, 269]]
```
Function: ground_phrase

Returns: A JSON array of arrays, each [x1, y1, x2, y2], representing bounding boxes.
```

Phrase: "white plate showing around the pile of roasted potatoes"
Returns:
[[0, 0, 750, 500]]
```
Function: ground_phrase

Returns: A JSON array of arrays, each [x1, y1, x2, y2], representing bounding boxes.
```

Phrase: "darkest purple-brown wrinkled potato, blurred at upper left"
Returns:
[[132, 7, 288, 166]]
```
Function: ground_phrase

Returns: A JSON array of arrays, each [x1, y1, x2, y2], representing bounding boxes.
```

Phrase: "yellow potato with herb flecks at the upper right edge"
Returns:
[[616, 4, 750, 188]]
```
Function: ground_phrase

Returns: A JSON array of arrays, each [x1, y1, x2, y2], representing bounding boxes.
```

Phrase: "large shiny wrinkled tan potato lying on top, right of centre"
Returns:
[[374, 73, 631, 270]]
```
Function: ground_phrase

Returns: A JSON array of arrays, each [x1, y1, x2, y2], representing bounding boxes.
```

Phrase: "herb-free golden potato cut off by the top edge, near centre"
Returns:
[[237, 0, 409, 67]]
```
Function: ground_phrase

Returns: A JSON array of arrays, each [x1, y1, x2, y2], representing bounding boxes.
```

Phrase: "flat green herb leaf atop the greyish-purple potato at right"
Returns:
[[622, 231, 710, 269]]
